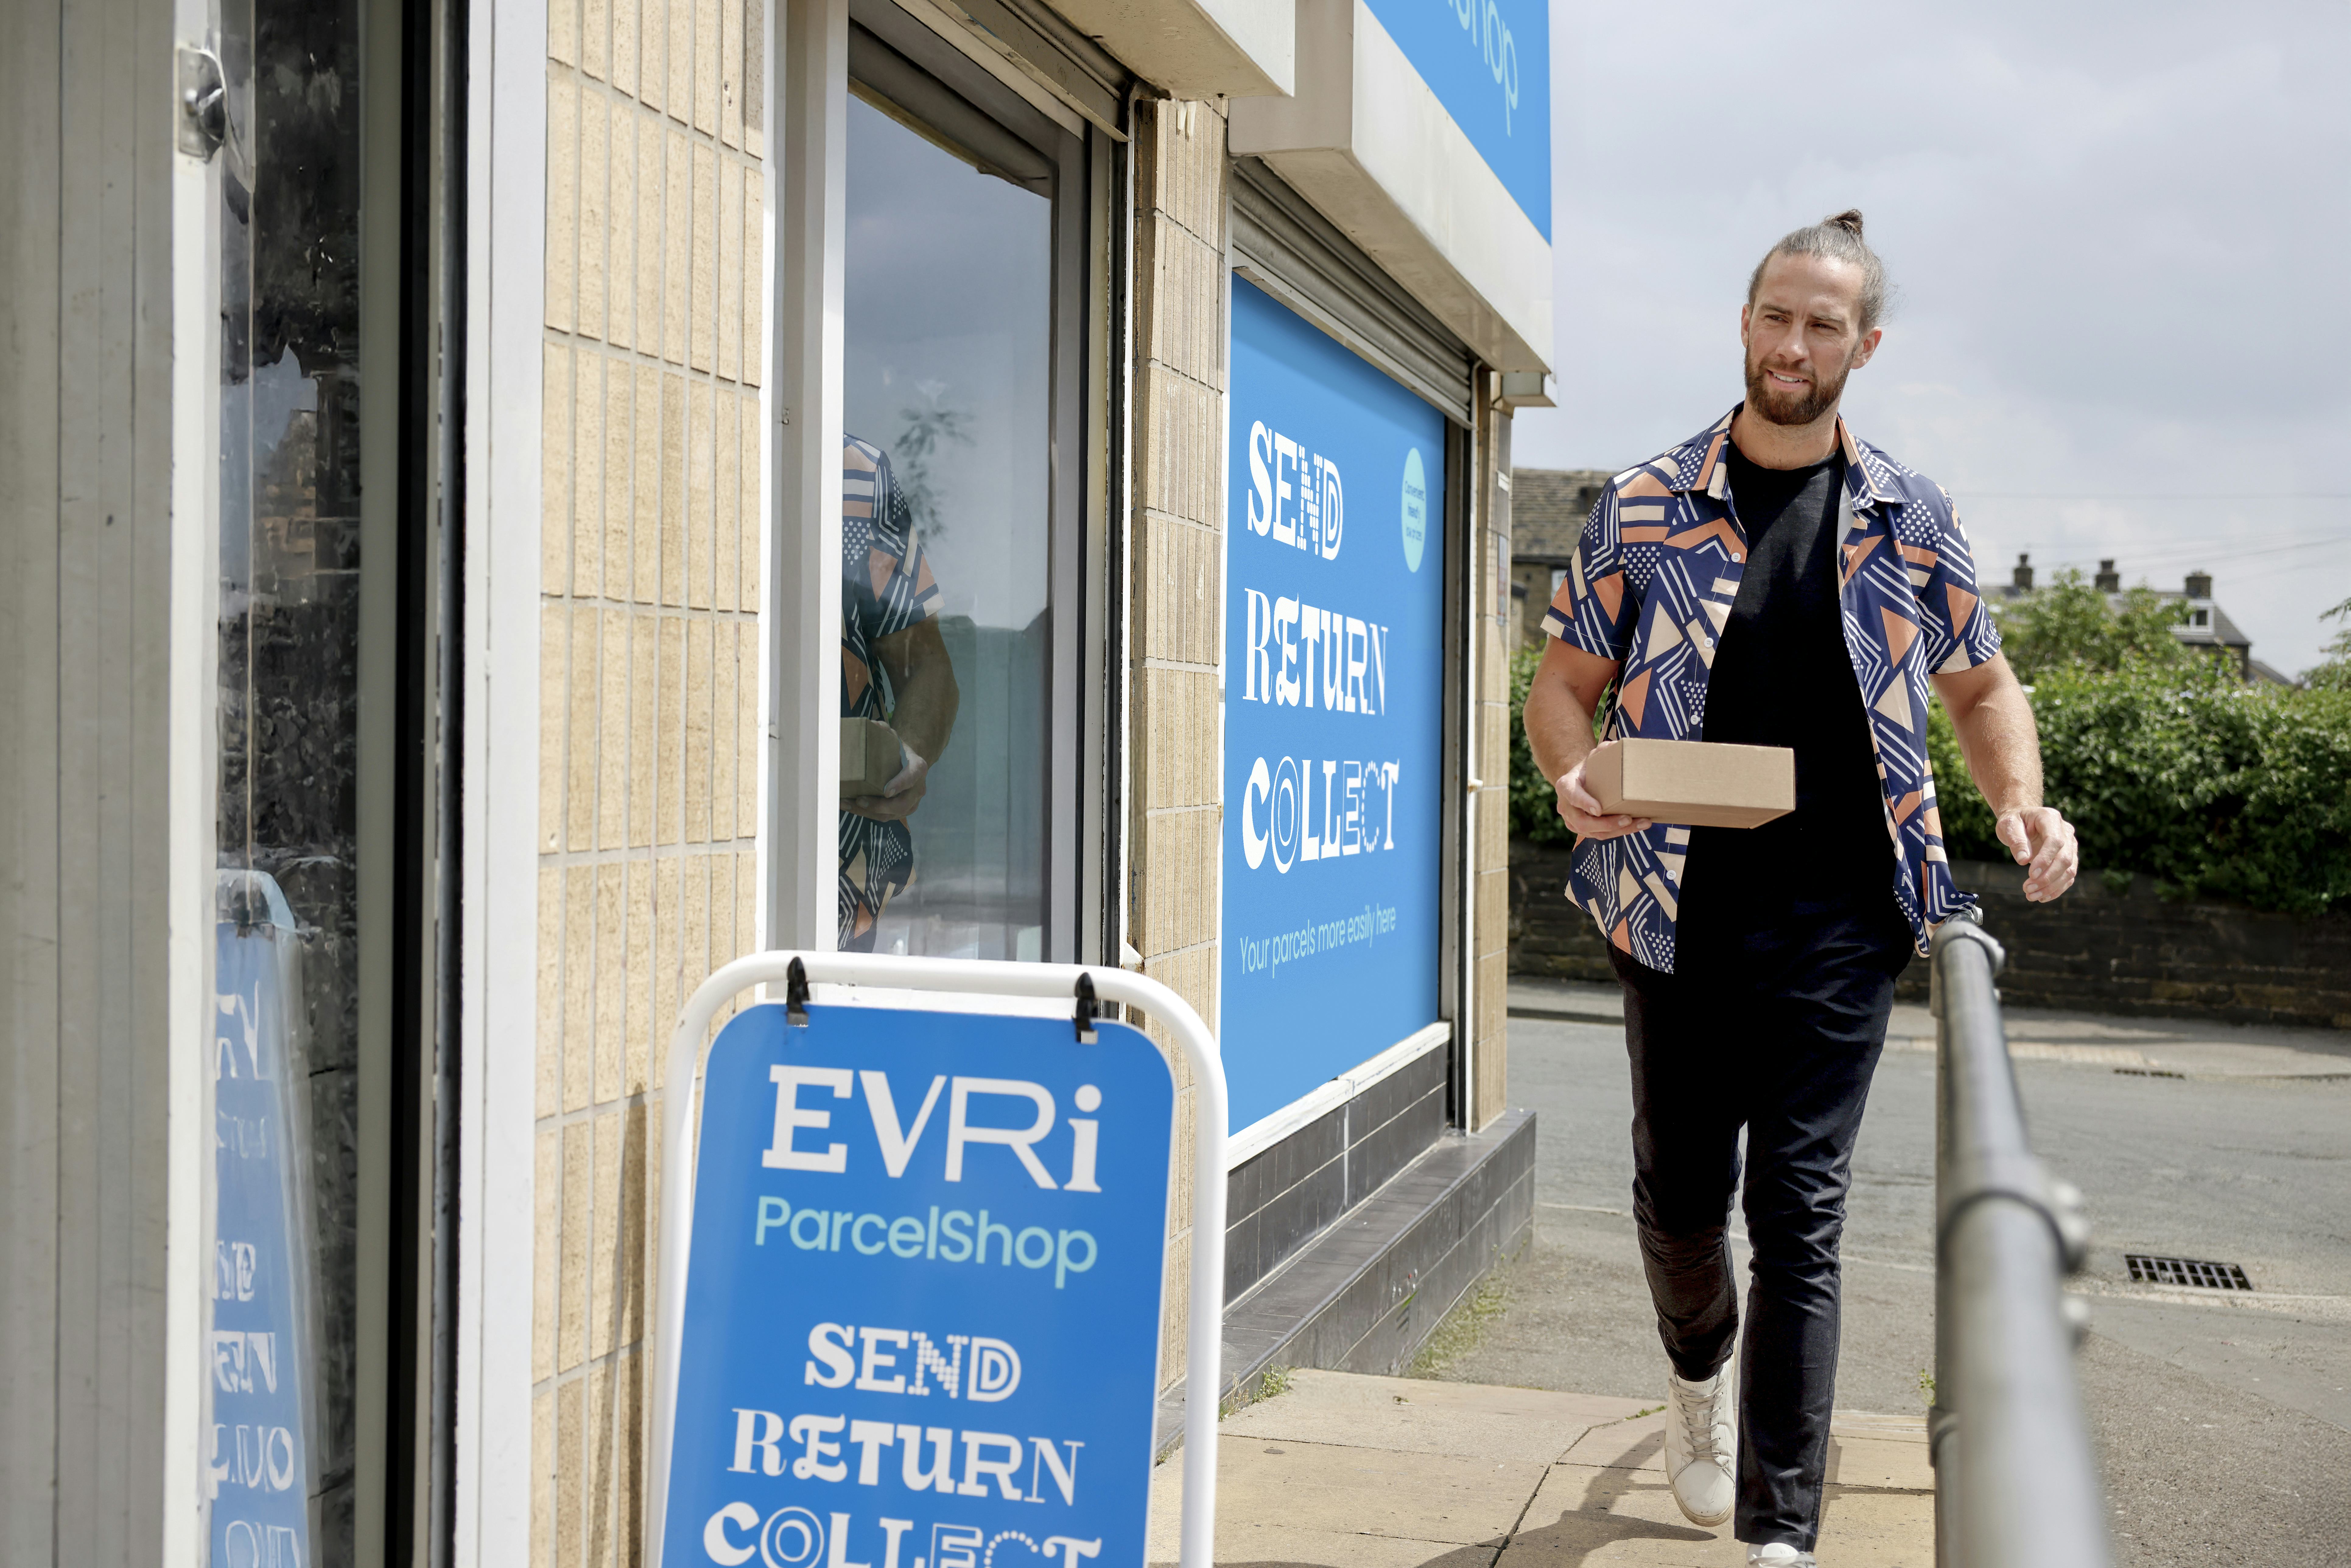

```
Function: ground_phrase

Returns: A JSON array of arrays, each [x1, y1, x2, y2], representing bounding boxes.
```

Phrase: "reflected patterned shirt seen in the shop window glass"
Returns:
[[839, 435, 938, 947]]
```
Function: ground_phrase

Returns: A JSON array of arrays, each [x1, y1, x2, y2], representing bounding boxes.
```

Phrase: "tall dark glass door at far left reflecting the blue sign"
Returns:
[[183, 0, 376, 1568]]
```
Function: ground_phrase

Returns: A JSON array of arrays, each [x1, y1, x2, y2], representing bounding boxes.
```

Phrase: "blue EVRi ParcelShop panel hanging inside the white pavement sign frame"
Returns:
[[661, 1004, 1176, 1568]]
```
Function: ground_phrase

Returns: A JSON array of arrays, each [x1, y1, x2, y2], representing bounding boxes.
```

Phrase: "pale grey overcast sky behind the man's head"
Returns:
[[1514, 0, 2351, 672]]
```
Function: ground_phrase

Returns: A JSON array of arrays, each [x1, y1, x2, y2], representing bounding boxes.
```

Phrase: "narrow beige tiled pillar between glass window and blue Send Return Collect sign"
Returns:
[[1126, 101, 1225, 1382]]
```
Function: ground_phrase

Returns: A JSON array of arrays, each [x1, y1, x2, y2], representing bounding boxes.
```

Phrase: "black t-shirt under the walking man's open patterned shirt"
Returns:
[[1681, 442, 1895, 928]]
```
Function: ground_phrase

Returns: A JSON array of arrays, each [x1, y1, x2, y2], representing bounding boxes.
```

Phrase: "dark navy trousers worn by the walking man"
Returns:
[[1610, 896, 1911, 1552]]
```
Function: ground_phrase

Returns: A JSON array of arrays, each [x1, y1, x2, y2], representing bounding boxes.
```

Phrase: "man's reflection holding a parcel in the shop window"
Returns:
[[839, 435, 957, 952]]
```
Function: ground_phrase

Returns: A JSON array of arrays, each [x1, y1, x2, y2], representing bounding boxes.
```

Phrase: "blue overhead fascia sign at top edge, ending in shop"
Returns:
[[1363, 0, 1552, 240]]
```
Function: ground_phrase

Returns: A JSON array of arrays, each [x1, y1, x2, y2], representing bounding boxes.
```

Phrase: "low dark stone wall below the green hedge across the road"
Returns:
[[1509, 842, 2351, 1030]]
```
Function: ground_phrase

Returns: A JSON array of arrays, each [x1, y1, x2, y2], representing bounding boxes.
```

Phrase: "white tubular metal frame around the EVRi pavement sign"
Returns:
[[644, 952, 1225, 1568]]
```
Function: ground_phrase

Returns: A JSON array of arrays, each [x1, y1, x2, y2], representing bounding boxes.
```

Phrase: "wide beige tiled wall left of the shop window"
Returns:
[[529, 0, 767, 1568]]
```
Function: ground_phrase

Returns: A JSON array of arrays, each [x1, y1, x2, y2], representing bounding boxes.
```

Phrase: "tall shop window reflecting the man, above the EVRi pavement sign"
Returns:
[[839, 7, 1084, 959]]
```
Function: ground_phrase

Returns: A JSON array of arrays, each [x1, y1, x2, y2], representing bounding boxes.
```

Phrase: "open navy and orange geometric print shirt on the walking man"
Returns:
[[1542, 409, 2001, 973]]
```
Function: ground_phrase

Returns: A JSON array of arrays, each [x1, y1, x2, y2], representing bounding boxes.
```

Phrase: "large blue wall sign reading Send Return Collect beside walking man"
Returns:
[[1218, 277, 1446, 1131]]
